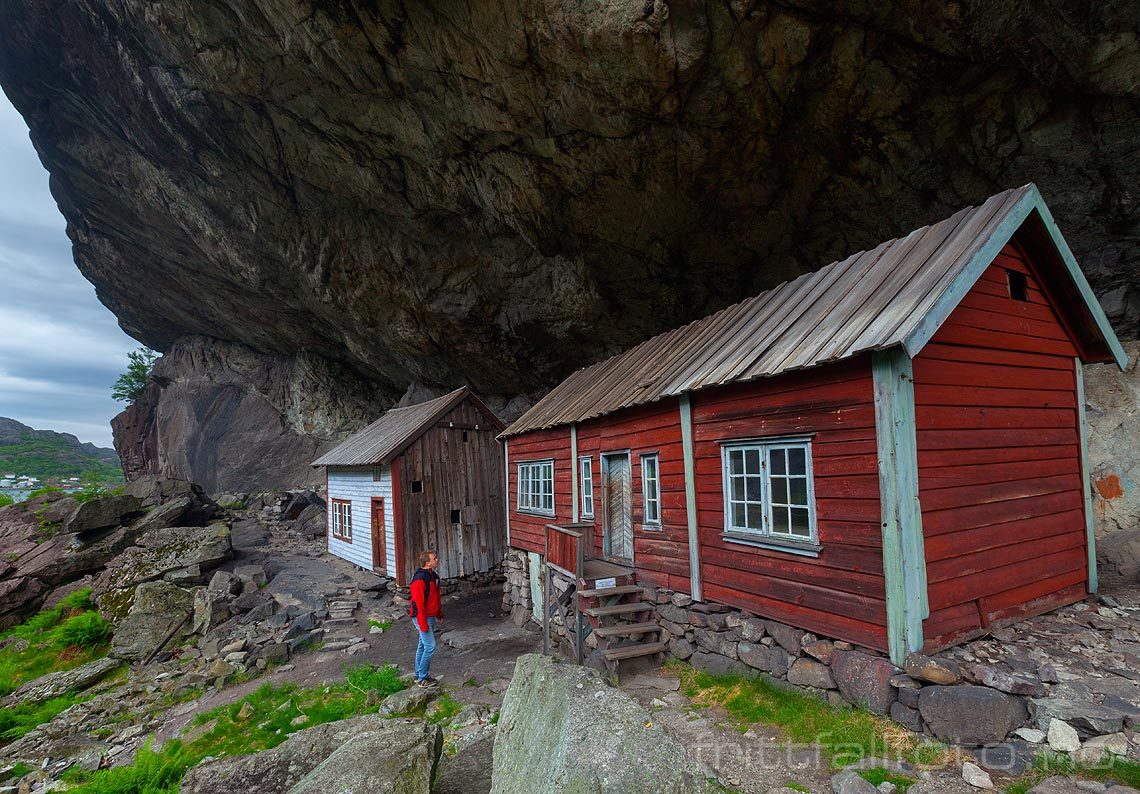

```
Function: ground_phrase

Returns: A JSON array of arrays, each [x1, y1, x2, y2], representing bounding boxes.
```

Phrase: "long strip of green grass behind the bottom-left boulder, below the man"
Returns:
[[62, 665, 406, 794]]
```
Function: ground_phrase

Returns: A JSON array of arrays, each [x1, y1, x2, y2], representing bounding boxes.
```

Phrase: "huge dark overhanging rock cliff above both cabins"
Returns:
[[0, 0, 1140, 487]]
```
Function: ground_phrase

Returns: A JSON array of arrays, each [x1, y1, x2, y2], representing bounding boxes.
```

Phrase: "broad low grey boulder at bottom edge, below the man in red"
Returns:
[[179, 714, 443, 794]]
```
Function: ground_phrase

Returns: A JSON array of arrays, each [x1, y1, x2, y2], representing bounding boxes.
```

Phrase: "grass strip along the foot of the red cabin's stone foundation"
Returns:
[[668, 663, 947, 768]]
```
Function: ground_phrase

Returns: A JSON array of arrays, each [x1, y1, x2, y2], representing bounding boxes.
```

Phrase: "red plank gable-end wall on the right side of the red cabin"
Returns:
[[914, 244, 1088, 650]]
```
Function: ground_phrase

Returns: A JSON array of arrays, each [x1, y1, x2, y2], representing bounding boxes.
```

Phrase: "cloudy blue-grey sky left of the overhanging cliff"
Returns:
[[0, 92, 139, 447]]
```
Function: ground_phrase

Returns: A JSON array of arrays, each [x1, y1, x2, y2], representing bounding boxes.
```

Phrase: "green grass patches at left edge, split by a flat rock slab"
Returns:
[[0, 590, 111, 744]]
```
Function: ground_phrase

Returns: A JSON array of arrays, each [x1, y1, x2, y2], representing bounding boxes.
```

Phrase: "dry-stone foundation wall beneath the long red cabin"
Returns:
[[503, 550, 1140, 746]]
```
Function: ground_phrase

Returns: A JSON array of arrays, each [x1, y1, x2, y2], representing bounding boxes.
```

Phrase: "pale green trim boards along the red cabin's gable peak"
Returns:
[[903, 185, 1129, 372]]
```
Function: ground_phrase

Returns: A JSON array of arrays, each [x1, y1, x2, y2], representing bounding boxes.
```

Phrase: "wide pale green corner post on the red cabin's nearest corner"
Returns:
[[871, 348, 930, 665]]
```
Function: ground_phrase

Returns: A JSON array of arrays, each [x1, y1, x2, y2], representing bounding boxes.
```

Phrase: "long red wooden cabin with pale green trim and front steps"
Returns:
[[500, 185, 1126, 663]]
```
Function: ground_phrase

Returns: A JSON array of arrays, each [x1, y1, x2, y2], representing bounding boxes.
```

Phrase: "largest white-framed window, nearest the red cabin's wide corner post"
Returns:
[[722, 439, 816, 543]]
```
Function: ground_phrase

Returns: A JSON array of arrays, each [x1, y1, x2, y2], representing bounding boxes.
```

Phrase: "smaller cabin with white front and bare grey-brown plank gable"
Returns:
[[312, 387, 506, 585]]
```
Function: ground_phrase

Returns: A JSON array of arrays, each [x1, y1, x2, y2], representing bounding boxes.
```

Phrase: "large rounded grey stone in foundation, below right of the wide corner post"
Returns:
[[919, 684, 1029, 747]]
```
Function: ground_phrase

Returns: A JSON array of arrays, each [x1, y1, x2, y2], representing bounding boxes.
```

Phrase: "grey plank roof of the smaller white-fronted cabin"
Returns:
[[311, 386, 504, 467]]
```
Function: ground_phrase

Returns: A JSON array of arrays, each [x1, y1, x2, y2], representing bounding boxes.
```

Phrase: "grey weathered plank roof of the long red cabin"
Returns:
[[503, 184, 1127, 436]]
